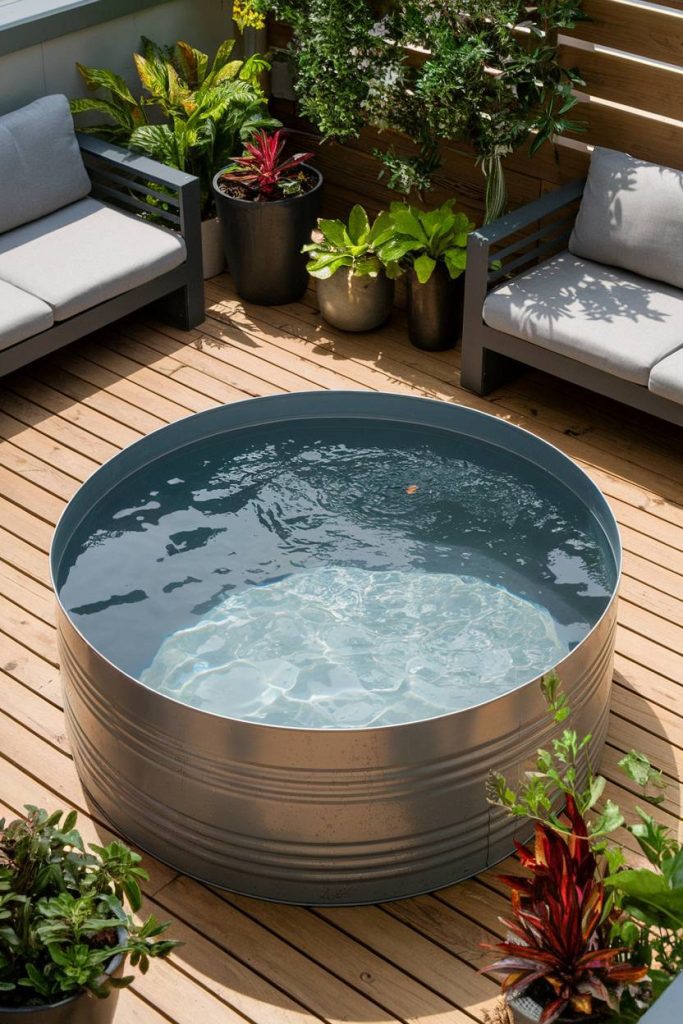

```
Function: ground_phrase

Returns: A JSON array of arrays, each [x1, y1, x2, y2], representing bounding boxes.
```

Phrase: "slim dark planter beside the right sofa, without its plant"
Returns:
[[408, 263, 465, 352]]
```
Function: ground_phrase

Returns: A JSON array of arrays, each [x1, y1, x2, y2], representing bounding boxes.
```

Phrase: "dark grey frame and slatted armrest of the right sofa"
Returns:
[[461, 178, 683, 426]]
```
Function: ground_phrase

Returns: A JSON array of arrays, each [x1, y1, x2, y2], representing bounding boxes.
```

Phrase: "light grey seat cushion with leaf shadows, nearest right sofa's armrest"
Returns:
[[483, 252, 683, 386]]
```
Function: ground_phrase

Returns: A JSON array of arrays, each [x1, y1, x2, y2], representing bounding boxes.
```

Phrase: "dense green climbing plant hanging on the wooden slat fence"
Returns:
[[249, 0, 583, 220]]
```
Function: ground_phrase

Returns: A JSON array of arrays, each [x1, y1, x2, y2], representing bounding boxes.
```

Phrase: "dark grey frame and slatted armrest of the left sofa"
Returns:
[[0, 132, 205, 376]]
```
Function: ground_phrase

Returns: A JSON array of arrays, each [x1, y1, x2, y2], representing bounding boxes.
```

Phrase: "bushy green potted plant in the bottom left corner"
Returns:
[[0, 806, 177, 1024]]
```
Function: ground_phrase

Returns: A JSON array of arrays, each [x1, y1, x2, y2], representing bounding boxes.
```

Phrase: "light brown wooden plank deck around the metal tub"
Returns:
[[0, 278, 683, 1024]]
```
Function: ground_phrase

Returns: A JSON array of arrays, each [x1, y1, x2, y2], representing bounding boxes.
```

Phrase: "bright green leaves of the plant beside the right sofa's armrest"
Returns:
[[380, 200, 474, 285]]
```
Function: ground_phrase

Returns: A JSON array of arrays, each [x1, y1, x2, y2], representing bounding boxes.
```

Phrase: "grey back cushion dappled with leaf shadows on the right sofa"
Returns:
[[569, 146, 683, 288]]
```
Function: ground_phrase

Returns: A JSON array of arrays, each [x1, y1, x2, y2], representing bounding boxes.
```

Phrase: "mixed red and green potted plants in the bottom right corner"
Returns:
[[488, 673, 683, 1024]]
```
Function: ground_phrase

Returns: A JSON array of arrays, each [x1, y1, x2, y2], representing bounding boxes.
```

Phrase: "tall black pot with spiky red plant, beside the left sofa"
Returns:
[[213, 130, 323, 306]]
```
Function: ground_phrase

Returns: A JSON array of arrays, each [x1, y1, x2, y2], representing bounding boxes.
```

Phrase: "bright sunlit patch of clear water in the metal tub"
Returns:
[[140, 566, 567, 729]]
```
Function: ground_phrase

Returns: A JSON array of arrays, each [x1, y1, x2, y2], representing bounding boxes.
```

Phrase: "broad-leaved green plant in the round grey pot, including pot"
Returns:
[[303, 206, 399, 331]]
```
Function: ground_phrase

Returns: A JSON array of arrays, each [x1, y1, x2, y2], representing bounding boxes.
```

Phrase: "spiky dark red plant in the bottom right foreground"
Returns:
[[484, 797, 647, 1024]]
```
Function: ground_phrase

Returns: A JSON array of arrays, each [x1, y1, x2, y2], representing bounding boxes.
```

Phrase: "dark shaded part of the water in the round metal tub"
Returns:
[[58, 421, 615, 720]]
